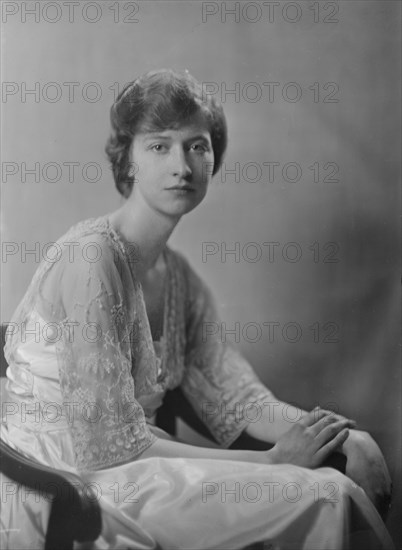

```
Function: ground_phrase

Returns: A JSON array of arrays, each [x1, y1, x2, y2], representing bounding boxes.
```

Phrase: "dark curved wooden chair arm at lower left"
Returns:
[[0, 440, 102, 548]]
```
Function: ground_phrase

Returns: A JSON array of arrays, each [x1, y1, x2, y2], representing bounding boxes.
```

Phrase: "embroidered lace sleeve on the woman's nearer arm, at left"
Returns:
[[49, 235, 156, 470]]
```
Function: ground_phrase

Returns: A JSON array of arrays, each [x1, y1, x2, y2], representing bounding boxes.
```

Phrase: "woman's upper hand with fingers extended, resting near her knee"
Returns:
[[268, 408, 355, 468]]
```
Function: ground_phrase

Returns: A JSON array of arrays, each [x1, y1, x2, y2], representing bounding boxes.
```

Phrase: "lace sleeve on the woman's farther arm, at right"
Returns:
[[182, 268, 275, 447]]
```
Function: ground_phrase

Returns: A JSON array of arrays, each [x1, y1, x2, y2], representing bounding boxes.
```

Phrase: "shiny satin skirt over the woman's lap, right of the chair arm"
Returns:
[[81, 458, 390, 550]]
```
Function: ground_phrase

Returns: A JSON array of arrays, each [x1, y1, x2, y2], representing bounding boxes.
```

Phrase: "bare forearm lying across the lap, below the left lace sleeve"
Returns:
[[139, 438, 273, 464]]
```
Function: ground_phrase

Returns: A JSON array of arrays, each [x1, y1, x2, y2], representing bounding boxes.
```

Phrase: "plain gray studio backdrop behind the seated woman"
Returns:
[[1, 0, 401, 540]]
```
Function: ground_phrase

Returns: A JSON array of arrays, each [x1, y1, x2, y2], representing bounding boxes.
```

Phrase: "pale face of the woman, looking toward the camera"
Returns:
[[130, 116, 214, 217]]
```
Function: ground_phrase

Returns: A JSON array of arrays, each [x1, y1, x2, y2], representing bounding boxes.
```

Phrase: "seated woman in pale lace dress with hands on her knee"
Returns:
[[2, 70, 392, 550]]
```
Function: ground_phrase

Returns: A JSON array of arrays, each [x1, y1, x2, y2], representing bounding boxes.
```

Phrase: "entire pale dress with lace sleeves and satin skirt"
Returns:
[[0, 216, 392, 550]]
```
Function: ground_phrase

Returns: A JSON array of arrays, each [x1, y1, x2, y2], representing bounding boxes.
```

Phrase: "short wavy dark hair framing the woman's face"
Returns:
[[105, 69, 227, 198]]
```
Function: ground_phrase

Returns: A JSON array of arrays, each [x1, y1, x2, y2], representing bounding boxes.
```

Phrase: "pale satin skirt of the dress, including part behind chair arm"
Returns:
[[1, 424, 393, 550]]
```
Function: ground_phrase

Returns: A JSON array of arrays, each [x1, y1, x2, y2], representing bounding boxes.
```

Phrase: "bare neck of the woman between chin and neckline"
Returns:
[[109, 195, 180, 280]]
